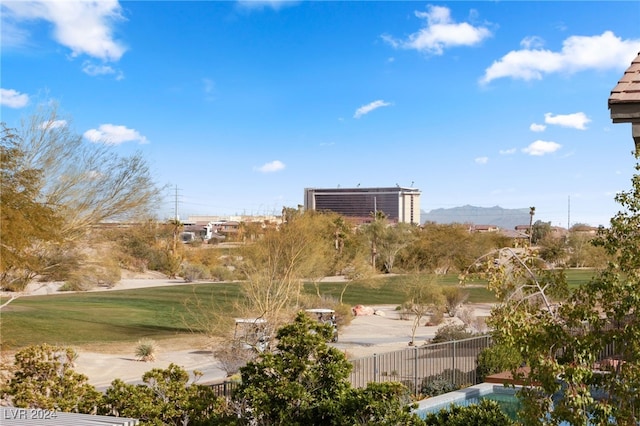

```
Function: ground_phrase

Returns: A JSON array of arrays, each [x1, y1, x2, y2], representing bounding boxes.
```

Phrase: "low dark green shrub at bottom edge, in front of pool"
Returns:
[[425, 399, 516, 426]]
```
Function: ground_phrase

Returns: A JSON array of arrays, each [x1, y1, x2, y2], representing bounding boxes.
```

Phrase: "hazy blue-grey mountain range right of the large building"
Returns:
[[420, 205, 536, 229]]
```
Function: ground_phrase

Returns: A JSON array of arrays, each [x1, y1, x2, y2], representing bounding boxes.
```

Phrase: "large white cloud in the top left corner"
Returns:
[[2, 0, 126, 61]]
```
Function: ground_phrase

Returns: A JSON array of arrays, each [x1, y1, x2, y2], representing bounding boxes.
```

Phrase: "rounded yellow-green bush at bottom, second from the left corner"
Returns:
[[100, 364, 226, 426]]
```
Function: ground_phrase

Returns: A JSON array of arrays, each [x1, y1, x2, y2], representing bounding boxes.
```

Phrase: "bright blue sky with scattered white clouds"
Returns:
[[0, 0, 640, 226]]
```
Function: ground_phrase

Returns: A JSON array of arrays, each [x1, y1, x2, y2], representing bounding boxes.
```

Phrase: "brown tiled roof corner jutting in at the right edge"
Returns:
[[609, 53, 640, 123]]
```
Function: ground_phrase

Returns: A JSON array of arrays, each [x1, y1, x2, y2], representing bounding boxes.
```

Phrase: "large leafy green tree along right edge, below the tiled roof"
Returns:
[[482, 157, 640, 425]]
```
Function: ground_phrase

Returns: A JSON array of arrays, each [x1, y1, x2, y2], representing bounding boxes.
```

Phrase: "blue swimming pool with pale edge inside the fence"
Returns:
[[415, 383, 520, 420]]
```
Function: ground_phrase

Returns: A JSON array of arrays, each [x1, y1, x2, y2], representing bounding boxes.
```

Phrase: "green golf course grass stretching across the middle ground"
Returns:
[[1, 270, 593, 348]]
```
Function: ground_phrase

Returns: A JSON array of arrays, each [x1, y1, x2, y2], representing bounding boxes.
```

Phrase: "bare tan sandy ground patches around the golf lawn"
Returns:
[[6, 276, 491, 388]]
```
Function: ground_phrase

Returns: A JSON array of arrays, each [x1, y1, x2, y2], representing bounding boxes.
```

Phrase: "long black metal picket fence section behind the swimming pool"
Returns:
[[350, 335, 492, 389]]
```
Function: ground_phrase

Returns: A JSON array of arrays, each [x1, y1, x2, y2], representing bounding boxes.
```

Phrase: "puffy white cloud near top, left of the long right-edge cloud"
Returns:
[[382, 5, 491, 55]]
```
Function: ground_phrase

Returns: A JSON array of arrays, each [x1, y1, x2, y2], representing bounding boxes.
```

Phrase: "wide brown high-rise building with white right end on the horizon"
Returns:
[[304, 186, 420, 225]]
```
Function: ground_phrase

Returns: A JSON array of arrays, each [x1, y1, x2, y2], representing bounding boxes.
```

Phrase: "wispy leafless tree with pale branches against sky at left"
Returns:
[[17, 101, 160, 239]]
